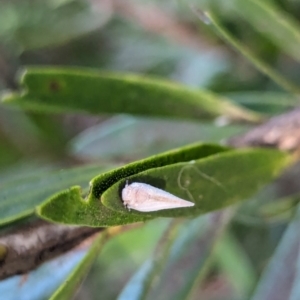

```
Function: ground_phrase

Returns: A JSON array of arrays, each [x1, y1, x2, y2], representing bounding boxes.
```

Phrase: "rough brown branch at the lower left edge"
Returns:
[[0, 220, 103, 279]]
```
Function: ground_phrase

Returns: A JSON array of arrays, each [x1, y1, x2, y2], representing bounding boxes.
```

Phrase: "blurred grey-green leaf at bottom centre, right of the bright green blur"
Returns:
[[147, 211, 231, 300]]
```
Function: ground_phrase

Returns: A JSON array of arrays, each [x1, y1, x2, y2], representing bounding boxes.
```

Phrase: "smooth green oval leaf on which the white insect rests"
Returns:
[[101, 149, 287, 217]]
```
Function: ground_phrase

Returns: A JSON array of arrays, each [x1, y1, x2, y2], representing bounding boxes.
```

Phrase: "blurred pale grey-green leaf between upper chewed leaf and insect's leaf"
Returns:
[[69, 115, 249, 161]]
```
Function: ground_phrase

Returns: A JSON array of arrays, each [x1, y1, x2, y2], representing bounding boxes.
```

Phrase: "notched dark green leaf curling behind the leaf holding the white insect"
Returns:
[[37, 144, 228, 227]]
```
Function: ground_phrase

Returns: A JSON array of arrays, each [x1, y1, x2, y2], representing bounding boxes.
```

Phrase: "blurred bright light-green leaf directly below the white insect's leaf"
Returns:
[[84, 218, 172, 300]]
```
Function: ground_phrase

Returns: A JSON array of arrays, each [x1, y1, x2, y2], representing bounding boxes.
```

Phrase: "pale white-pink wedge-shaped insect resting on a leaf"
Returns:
[[122, 182, 195, 212]]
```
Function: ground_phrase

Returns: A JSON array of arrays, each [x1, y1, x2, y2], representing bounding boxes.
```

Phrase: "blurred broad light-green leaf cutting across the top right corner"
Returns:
[[232, 0, 300, 61]]
